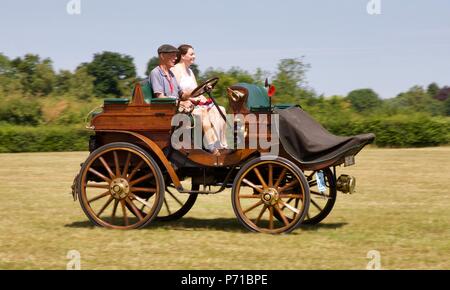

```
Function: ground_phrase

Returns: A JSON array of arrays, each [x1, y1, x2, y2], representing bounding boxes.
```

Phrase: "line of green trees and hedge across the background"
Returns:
[[0, 51, 450, 126]]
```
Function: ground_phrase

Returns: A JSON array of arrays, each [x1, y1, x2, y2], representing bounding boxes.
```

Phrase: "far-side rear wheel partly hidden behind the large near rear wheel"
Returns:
[[156, 184, 199, 221]]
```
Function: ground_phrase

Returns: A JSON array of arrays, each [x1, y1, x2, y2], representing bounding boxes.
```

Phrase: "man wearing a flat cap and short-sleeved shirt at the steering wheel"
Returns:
[[149, 44, 189, 102]]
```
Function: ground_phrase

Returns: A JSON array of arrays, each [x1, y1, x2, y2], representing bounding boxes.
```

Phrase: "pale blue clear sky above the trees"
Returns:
[[0, 0, 450, 98]]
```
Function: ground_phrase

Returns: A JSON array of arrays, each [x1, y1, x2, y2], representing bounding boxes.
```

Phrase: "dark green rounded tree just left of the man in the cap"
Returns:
[[86, 51, 136, 97]]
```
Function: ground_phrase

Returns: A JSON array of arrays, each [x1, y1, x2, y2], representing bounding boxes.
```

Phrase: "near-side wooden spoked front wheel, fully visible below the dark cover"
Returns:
[[231, 157, 309, 234]]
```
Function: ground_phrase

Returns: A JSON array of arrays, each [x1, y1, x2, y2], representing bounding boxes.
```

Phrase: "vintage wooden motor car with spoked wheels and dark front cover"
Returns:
[[72, 78, 375, 234]]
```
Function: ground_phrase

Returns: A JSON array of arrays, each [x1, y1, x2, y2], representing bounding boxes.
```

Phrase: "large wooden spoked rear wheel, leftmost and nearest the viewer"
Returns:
[[78, 142, 165, 229]]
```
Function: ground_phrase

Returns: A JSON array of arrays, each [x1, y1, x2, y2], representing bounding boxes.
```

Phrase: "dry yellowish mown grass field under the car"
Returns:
[[0, 147, 450, 269]]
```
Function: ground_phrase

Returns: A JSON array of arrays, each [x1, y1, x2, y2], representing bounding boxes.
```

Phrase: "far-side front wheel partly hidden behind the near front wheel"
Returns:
[[275, 168, 337, 225]]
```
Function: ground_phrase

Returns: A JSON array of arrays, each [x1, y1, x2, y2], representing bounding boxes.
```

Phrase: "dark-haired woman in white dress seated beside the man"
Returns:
[[172, 44, 227, 155]]
